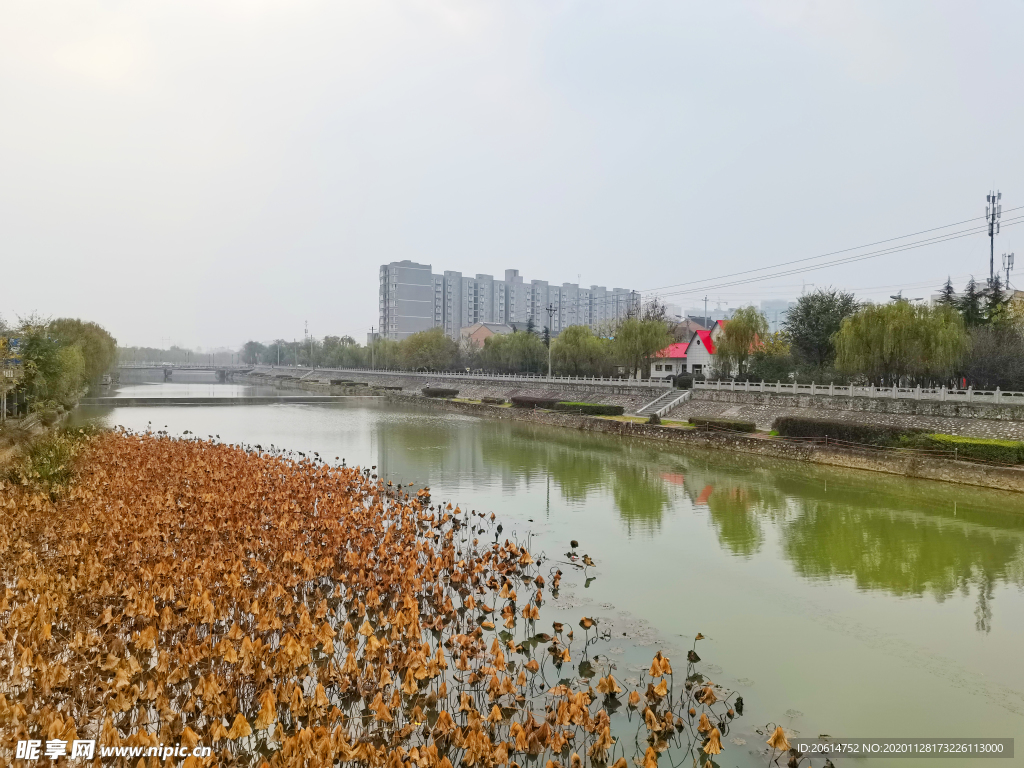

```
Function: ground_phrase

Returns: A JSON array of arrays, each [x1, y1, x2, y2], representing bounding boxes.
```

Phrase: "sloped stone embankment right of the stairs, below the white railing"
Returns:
[[666, 389, 1024, 439]]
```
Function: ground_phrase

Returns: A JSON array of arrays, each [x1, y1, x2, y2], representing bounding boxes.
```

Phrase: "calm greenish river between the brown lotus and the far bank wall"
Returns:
[[76, 384, 1024, 767]]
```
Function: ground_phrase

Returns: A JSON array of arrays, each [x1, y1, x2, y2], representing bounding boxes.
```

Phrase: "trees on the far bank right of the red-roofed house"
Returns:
[[712, 276, 1024, 390]]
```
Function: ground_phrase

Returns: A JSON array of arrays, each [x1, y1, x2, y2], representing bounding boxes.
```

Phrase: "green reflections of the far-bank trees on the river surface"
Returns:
[[377, 416, 1024, 632]]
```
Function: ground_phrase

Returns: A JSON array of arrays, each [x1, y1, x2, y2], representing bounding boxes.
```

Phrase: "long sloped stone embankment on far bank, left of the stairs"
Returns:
[[232, 367, 668, 414]]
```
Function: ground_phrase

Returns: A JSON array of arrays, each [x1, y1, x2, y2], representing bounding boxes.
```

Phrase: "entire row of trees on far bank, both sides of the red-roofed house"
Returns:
[[228, 278, 1024, 390]]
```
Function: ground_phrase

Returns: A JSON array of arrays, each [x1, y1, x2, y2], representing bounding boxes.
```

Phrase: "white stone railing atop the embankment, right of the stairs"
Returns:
[[693, 380, 1024, 406]]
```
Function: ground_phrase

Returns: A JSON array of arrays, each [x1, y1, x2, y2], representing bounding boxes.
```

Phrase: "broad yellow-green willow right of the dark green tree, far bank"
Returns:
[[835, 301, 971, 384]]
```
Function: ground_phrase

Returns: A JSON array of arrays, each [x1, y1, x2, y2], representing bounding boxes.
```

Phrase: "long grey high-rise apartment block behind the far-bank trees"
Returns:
[[379, 261, 640, 340]]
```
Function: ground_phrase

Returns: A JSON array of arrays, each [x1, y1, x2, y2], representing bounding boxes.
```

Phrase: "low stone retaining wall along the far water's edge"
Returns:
[[388, 392, 1024, 493]]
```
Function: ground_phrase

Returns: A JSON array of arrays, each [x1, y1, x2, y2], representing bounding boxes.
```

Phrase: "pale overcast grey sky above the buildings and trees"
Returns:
[[0, 0, 1024, 348]]
